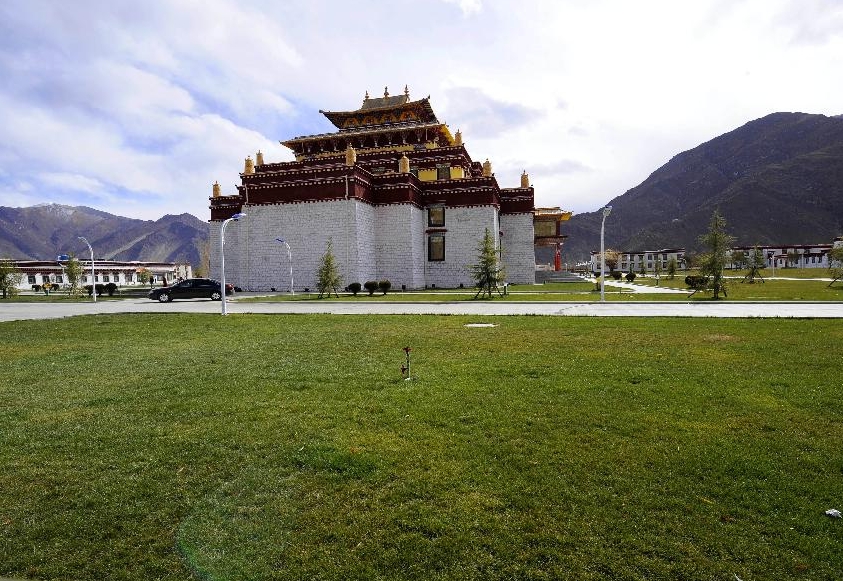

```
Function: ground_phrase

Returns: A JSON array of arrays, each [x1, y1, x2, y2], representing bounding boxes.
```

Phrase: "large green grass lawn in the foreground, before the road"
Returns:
[[0, 314, 843, 581]]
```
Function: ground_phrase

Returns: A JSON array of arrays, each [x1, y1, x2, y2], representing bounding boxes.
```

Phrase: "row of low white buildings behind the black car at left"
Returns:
[[5, 259, 193, 290]]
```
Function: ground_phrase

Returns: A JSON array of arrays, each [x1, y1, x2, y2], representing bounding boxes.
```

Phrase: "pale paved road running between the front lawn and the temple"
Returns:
[[0, 295, 843, 322]]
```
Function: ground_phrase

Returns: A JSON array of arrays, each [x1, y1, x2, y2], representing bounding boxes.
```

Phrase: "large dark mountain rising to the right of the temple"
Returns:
[[563, 113, 843, 263]]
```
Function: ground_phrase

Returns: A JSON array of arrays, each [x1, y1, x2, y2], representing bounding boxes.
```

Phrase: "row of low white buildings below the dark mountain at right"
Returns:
[[589, 238, 843, 272]]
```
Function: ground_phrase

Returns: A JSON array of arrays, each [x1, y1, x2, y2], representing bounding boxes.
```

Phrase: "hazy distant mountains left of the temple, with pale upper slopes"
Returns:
[[0, 204, 208, 266]]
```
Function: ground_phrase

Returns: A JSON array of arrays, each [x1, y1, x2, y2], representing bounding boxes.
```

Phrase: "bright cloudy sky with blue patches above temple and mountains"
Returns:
[[0, 0, 843, 219]]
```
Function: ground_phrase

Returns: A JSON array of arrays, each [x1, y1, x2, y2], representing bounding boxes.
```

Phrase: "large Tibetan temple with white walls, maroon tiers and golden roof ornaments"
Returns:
[[210, 87, 562, 291]]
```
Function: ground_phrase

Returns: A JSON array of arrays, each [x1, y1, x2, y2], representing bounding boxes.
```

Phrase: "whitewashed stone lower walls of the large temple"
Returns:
[[210, 200, 535, 292]]
